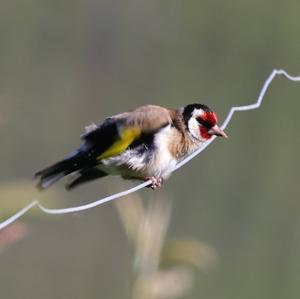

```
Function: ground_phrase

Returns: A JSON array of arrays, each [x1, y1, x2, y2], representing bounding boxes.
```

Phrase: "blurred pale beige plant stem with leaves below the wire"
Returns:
[[115, 194, 217, 299]]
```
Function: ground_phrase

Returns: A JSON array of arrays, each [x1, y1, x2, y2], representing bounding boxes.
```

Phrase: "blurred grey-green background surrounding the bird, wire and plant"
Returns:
[[0, 0, 300, 299]]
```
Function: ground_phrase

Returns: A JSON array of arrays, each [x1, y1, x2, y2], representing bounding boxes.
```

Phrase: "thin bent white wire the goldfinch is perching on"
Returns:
[[0, 69, 300, 230]]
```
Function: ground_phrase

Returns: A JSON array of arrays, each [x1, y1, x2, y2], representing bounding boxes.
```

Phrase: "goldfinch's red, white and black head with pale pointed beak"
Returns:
[[183, 104, 227, 142]]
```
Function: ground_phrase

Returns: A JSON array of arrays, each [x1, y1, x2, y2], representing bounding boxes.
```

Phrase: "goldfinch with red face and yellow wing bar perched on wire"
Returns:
[[35, 103, 227, 190]]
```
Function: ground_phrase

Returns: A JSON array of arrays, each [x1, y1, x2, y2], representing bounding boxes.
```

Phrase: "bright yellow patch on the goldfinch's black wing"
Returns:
[[98, 127, 141, 160]]
